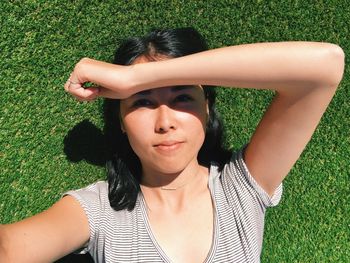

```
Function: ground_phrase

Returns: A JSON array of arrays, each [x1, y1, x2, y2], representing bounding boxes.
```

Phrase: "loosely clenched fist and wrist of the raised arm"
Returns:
[[64, 58, 134, 101]]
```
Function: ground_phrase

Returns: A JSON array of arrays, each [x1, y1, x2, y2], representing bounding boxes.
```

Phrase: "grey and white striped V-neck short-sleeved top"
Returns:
[[66, 150, 282, 263]]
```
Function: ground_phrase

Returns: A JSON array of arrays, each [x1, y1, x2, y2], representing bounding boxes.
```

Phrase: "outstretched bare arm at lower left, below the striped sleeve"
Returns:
[[0, 196, 89, 263]]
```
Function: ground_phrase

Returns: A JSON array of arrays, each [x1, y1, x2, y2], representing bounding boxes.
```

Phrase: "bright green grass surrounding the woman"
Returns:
[[0, 0, 350, 262]]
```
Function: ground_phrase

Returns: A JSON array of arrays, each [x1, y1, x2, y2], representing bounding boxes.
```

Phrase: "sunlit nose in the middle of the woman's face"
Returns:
[[155, 105, 176, 133]]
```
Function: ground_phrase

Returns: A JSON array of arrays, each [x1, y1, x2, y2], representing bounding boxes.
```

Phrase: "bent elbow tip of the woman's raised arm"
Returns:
[[323, 44, 345, 89]]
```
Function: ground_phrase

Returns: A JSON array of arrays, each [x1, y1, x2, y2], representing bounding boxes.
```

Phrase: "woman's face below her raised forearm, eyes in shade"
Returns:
[[120, 81, 208, 174]]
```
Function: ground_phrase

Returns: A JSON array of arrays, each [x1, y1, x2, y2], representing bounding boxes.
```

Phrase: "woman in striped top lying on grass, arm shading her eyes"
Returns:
[[0, 28, 344, 262]]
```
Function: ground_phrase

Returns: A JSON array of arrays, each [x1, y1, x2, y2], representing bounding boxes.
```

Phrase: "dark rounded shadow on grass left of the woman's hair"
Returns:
[[64, 120, 106, 166]]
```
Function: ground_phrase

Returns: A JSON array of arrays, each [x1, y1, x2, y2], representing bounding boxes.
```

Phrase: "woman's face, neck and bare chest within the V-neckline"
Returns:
[[120, 58, 213, 262]]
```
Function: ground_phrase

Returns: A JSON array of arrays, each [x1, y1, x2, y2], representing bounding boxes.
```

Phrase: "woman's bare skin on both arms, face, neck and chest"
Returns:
[[0, 42, 344, 262]]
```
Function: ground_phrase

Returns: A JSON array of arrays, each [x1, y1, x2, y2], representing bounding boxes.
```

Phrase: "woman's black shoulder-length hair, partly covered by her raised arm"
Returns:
[[104, 27, 231, 211]]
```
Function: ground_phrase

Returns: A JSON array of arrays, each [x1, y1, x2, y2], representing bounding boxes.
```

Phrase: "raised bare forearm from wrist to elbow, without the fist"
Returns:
[[134, 42, 344, 92]]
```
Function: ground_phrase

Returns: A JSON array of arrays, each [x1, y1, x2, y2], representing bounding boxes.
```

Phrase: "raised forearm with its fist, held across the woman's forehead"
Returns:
[[65, 42, 344, 100]]
